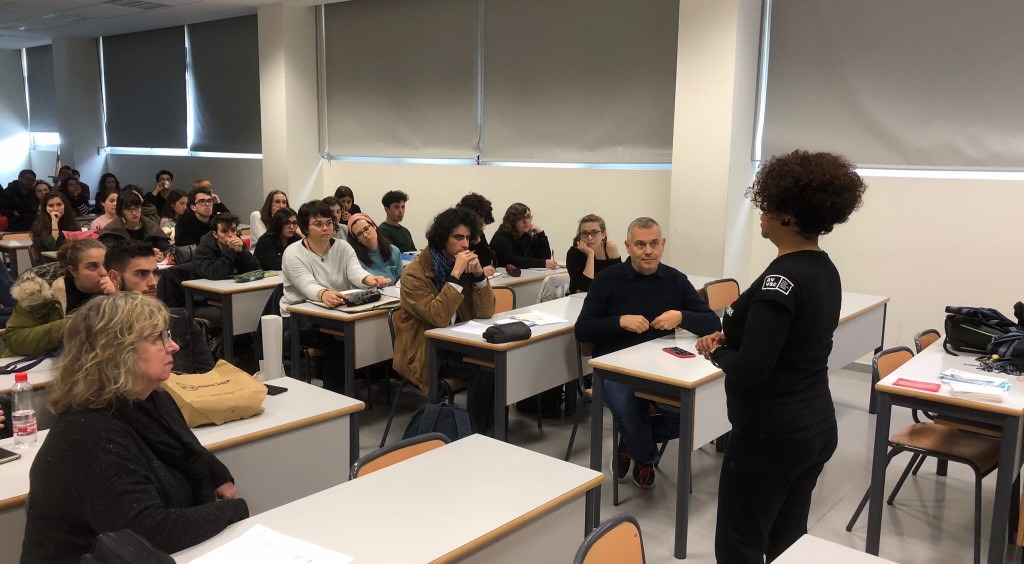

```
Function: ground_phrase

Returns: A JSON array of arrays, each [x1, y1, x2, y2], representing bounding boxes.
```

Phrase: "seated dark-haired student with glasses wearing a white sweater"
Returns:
[[281, 201, 391, 393]]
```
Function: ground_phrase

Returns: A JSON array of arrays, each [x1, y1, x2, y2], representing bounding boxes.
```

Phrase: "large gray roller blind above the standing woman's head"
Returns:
[[762, 0, 1024, 169]]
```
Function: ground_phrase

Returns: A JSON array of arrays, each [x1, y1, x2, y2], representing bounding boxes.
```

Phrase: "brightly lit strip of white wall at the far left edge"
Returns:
[[0, 49, 29, 186]]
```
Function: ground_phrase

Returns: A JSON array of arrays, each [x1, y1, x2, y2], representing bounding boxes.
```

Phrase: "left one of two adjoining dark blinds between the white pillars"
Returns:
[[103, 27, 187, 148]]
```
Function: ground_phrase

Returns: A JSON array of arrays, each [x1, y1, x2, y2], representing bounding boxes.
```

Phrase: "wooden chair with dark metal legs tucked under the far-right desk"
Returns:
[[846, 347, 999, 563]]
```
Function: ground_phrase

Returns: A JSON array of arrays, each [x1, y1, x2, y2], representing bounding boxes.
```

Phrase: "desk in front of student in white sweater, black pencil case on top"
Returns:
[[287, 302, 398, 462]]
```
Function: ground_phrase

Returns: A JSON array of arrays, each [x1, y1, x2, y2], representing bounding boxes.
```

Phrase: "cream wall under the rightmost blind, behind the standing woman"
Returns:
[[742, 177, 1024, 347]]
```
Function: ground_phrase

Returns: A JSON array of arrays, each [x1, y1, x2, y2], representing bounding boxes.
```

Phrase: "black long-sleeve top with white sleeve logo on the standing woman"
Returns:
[[712, 251, 843, 437]]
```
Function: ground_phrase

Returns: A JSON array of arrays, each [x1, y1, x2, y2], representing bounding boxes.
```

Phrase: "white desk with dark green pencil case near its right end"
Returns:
[[181, 271, 284, 362]]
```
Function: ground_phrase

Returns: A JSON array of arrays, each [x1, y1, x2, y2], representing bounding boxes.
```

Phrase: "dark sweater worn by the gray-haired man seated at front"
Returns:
[[575, 260, 722, 356]]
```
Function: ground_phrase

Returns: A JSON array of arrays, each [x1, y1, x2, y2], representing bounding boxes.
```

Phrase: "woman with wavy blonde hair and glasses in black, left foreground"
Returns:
[[22, 292, 249, 563]]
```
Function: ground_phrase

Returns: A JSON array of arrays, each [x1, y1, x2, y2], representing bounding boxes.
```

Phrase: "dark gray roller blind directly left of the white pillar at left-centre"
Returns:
[[188, 15, 261, 153]]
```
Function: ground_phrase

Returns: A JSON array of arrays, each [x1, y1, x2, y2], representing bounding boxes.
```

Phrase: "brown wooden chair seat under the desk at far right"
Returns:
[[889, 423, 999, 473]]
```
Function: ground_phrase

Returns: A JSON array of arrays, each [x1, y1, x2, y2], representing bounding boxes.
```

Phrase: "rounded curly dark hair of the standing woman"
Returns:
[[748, 150, 866, 238]]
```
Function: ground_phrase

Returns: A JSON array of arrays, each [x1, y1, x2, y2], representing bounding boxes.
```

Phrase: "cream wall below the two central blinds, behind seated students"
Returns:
[[319, 161, 672, 257]]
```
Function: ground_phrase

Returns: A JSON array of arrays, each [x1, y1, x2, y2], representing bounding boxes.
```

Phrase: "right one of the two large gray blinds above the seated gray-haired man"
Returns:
[[481, 0, 679, 163]]
